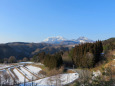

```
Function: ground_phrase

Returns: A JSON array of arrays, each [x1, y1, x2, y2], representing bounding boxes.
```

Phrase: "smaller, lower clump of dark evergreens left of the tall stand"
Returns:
[[32, 52, 63, 69]]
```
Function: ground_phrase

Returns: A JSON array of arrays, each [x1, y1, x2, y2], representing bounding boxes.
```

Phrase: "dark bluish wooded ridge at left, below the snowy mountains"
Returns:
[[0, 42, 69, 59]]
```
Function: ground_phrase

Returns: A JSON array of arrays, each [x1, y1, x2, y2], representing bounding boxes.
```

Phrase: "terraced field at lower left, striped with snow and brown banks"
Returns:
[[0, 65, 43, 85]]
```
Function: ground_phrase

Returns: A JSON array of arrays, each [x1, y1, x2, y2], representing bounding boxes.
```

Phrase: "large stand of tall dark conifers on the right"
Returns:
[[69, 41, 103, 68]]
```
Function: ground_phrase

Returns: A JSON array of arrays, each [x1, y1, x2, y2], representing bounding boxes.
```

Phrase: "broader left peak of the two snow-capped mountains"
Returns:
[[43, 36, 66, 44]]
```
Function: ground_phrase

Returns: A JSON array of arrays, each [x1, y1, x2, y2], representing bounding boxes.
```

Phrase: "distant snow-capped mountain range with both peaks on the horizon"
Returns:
[[43, 36, 93, 45]]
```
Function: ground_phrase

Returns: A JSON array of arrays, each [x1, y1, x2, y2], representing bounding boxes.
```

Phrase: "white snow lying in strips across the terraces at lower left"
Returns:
[[0, 64, 42, 83]]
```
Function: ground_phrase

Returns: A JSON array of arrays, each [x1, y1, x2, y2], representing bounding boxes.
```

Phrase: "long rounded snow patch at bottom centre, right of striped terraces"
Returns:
[[20, 73, 79, 86]]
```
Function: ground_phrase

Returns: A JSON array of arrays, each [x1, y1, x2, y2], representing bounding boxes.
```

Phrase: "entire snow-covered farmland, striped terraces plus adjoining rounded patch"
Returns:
[[0, 64, 79, 86]]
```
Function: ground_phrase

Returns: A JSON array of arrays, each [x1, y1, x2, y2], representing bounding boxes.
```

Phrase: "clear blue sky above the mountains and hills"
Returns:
[[0, 0, 115, 43]]
